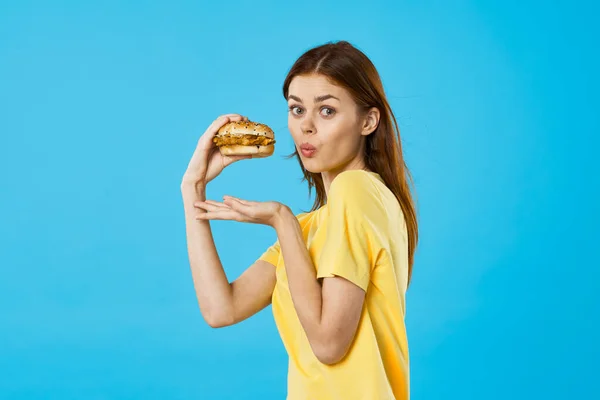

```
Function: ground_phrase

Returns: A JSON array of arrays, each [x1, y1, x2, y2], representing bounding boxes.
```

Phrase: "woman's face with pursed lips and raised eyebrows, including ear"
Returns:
[[288, 75, 374, 174]]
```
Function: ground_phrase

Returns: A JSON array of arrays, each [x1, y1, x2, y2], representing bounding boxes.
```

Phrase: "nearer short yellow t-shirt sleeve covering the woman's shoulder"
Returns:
[[316, 171, 387, 291]]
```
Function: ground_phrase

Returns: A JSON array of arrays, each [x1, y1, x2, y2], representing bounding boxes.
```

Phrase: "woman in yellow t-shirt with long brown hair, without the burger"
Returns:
[[182, 42, 417, 400]]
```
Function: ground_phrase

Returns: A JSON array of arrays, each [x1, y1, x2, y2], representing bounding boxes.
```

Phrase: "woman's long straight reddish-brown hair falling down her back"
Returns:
[[283, 41, 418, 283]]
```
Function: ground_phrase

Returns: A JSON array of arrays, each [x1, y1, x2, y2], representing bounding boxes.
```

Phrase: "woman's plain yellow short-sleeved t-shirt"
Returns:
[[255, 170, 409, 400]]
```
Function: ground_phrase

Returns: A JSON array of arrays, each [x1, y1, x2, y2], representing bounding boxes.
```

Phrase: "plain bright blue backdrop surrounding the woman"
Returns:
[[0, 0, 600, 400]]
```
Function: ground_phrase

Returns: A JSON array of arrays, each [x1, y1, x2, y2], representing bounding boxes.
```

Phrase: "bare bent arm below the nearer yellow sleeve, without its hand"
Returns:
[[273, 207, 365, 364]]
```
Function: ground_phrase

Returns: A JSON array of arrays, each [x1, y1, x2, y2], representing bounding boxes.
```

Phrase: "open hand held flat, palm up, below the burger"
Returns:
[[194, 196, 285, 227]]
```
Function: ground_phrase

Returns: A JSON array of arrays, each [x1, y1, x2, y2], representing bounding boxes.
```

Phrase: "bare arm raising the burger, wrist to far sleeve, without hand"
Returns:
[[181, 183, 276, 328]]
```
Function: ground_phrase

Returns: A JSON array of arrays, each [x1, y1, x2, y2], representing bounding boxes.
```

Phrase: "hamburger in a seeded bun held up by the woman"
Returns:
[[213, 121, 275, 158]]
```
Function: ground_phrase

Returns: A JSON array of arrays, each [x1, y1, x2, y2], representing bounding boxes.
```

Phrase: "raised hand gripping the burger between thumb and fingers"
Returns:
[[182, 114, 252, 186]]
